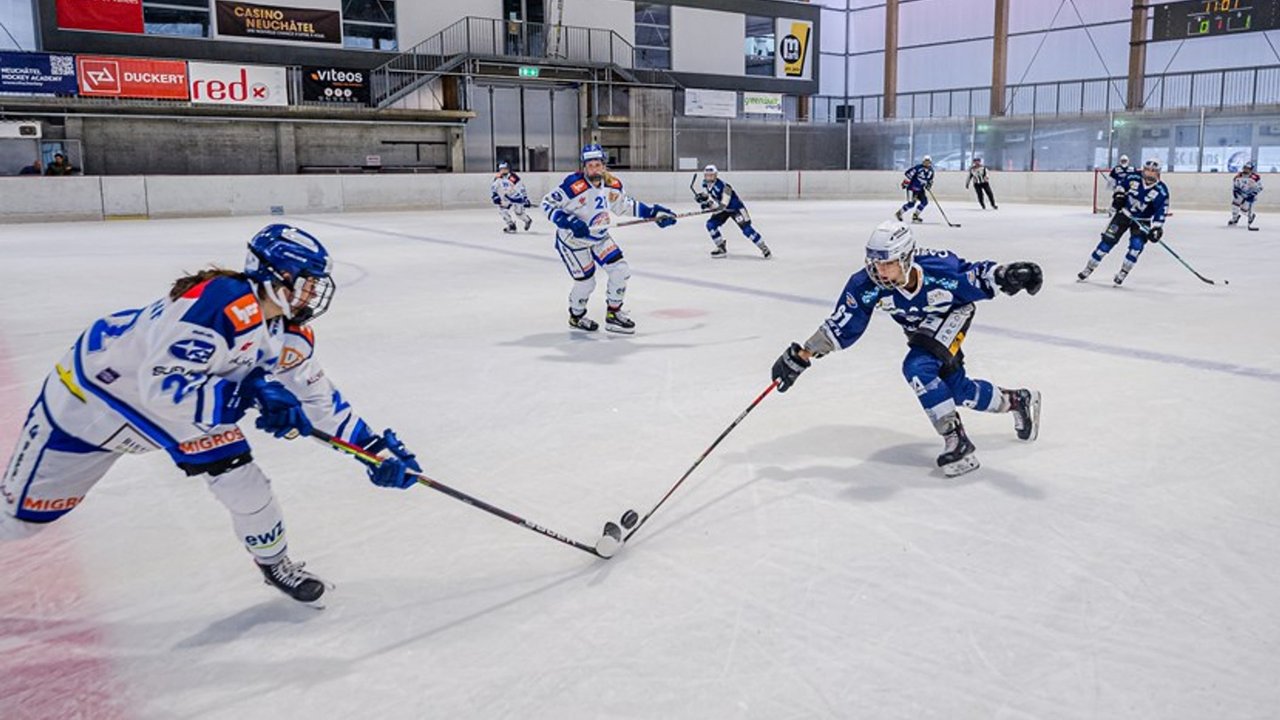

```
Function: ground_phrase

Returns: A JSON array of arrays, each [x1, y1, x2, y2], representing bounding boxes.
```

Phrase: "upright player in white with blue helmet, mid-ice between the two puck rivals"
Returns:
[[543, 143, 676, 334]]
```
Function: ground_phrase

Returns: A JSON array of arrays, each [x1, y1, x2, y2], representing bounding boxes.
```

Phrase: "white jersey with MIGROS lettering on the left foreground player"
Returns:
[[56, 271, 370, 457]]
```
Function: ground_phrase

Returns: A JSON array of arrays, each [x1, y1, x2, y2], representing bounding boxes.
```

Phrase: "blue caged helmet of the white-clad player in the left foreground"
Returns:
[[244, 224, 337, 325]]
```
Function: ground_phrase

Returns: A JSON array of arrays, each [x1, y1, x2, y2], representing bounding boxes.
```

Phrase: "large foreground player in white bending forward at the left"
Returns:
[[0, 224, 420, 602]]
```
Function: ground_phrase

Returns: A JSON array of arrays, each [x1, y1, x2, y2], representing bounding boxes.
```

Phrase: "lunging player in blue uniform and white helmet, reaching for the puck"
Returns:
[[773, 220, 1043, 477]]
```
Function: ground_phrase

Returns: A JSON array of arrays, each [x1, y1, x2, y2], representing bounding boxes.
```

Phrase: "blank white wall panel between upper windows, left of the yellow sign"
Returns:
[[671, 5, 746, 76]]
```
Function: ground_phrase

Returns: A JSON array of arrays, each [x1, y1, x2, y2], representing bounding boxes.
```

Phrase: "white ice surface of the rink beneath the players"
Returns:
[[0, 197, 1280, 720]]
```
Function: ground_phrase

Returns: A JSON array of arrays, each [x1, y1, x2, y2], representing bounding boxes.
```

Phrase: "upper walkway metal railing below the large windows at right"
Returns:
[[813, 65, 1280, 123]]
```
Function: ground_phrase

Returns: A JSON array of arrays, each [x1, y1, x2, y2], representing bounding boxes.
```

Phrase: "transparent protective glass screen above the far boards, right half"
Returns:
[[614, 108, 1280, 172]]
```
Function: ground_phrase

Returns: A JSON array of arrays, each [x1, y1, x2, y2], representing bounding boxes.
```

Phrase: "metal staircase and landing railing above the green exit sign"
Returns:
[[370, 17, 680, 108]]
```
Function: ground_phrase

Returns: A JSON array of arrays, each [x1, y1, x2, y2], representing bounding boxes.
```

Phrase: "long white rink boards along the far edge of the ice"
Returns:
[[0, 170, 1230, 223]]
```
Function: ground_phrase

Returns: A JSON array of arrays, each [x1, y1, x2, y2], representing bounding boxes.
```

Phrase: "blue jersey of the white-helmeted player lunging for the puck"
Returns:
[[823, 247, 996, 350]]
